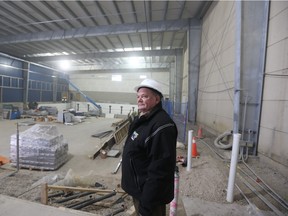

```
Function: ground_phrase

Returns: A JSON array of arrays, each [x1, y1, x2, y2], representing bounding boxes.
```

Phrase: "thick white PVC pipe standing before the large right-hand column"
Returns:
[[226, 133, 241, 203]]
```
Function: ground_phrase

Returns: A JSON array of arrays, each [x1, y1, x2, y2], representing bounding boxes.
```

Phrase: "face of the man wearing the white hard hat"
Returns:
[[137, 88, 160, 113]]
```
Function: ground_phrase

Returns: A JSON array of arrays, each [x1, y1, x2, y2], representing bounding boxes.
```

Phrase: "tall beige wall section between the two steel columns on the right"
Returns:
[[196, 1, 235, 134]]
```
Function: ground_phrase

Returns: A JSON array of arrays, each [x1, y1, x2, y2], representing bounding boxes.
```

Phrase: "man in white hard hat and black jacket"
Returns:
[[121, 79, 178, 216]]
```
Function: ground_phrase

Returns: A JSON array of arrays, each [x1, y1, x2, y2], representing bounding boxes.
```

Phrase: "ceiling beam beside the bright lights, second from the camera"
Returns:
[[25, 49, 183, 62]]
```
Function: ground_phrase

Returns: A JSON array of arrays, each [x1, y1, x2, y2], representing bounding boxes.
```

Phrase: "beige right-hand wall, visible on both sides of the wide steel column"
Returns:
[[197, 1, 288, 166]]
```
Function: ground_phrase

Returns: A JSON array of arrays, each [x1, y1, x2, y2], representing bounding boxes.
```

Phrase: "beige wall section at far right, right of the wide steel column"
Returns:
[[258, 1, 288, 166]]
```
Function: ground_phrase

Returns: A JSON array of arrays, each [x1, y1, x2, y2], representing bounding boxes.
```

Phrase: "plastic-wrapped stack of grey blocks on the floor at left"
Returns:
[[10, 124, 68, 170]]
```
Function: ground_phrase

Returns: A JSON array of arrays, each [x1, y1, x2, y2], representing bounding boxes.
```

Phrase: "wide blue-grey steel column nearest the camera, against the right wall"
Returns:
[[233, 0, 269, 155]]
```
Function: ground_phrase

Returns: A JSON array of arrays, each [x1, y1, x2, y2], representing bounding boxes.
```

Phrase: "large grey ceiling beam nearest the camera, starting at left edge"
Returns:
[[0, 19, 189, 45]]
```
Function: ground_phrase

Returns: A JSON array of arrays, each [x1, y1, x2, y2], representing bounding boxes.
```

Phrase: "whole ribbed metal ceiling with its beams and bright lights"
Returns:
[[0, 0, 211, 73]]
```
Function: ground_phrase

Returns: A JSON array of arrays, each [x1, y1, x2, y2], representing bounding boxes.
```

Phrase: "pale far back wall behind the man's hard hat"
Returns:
[[70, 72, 169, 104]]
